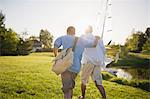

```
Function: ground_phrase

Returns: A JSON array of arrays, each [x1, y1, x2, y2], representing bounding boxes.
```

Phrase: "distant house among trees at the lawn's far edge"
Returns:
[[31, 40, 43, 52]]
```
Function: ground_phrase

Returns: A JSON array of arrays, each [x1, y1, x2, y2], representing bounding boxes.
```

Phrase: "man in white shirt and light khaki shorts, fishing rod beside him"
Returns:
[[79, 26, 106, 99]]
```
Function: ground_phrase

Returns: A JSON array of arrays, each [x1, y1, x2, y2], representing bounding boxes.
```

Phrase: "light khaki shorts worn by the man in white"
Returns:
[[81, 63, 102, 85]]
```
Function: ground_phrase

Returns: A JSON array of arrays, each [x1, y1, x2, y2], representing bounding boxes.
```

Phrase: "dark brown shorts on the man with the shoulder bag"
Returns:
[[61, 70, 77, 93]]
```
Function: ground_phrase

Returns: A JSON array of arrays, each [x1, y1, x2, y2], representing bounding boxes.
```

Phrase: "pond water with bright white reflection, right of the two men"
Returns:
[[106, 67, 150, 80]]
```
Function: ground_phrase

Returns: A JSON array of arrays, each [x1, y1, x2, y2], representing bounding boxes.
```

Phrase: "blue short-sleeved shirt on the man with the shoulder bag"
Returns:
[[54, 35, 94, 73]]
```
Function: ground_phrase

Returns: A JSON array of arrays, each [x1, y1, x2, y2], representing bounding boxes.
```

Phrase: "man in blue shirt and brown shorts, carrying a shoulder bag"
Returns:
[[54, 26, 84, 99]]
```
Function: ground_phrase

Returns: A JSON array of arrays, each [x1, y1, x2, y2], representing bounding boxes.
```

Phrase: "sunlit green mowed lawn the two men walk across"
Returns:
[[0, 53, 150, 99]]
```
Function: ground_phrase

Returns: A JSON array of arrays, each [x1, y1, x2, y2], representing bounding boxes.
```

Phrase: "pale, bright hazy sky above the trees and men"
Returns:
[[0, 0, 150, 44]]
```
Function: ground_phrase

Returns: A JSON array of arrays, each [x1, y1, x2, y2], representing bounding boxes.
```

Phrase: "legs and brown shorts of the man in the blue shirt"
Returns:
[[61, 70, 77, 99]]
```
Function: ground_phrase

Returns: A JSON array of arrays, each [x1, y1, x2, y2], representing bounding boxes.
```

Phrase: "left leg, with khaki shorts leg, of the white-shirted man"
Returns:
[[79, 63, 94, 99]]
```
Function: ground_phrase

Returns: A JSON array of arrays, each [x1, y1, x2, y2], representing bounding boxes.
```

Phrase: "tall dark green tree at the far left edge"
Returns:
[[0, 12, 19, 55]]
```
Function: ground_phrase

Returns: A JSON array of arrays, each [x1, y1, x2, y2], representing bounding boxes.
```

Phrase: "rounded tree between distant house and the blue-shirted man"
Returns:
[[40, 29, 53, 48]]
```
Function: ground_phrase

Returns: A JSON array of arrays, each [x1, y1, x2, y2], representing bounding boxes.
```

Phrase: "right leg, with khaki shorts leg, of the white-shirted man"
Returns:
[[92, 66, 106, 99]]
